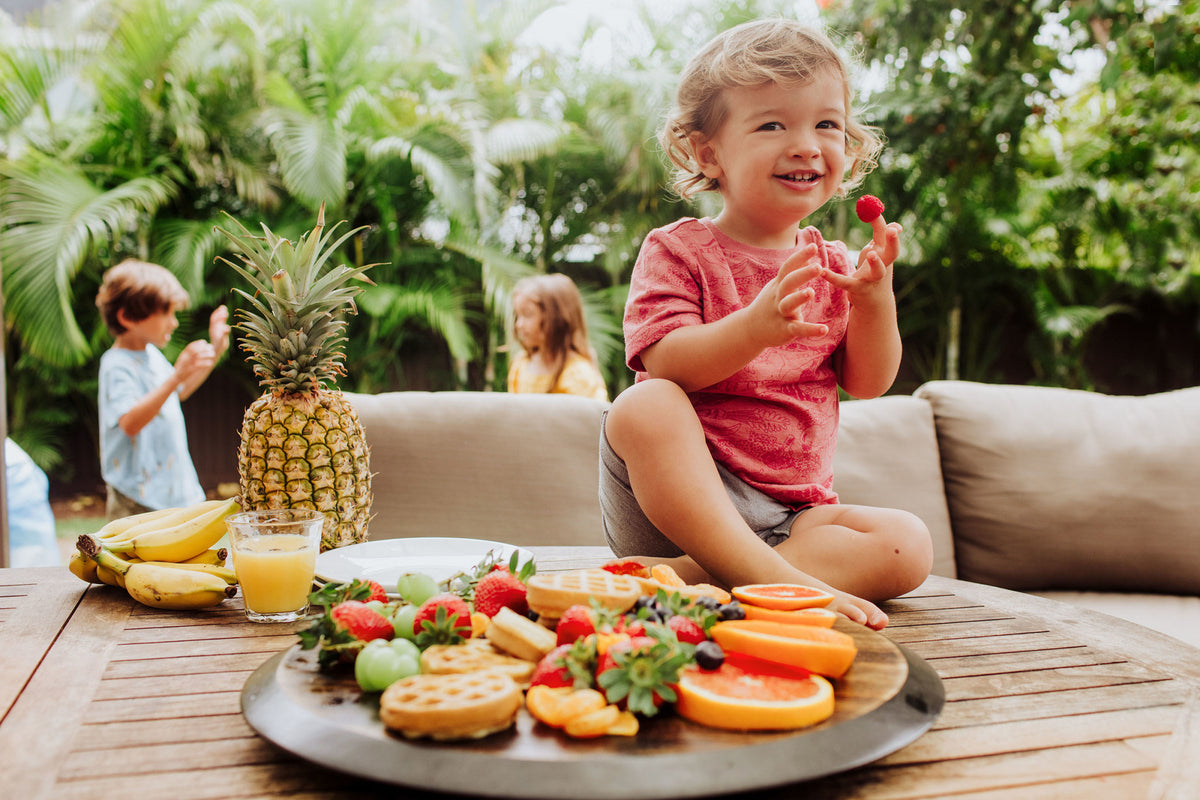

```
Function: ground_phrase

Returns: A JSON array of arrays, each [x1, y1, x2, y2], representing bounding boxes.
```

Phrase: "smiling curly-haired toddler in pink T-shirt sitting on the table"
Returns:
[[600, 20, 932, 628]]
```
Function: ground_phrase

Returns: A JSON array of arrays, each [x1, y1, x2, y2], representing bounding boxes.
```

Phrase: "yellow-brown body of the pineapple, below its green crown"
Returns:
[[238, 390, 372, 552]]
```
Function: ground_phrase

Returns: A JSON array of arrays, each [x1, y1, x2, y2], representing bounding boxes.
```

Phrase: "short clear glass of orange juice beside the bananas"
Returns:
[[233, 534, 317, 614]]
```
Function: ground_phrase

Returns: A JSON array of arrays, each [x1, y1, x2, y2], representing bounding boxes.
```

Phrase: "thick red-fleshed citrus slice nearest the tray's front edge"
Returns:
[[676, 652, 834, 730]]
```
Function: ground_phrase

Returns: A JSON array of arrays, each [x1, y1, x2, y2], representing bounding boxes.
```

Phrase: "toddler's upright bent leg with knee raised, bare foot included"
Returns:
[[605, 380, 887, 628]]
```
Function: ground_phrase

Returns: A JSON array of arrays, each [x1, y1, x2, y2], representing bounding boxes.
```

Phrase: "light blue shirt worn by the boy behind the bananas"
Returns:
[[98, 344, 204, 509]]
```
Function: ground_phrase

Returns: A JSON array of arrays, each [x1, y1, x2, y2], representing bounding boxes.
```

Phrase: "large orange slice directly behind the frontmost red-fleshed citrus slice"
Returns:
[[708, 619, 858, 678]]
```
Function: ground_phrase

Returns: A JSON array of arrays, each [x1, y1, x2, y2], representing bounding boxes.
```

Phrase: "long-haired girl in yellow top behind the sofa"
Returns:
[[508, 273, 608, 401]]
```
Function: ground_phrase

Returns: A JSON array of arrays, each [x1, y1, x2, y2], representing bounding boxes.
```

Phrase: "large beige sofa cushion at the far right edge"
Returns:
[[916, 381, 1200, 595]]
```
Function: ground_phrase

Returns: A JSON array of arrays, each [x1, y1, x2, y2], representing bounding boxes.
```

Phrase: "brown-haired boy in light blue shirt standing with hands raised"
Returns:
[[96, 259, 229, 519]]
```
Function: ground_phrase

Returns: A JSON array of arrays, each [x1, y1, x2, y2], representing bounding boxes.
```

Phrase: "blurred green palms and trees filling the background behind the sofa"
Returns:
[[0, 0, 1200, 501]]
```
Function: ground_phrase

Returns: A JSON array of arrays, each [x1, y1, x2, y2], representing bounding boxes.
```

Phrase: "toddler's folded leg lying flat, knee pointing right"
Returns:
[[775, 505, 934, 602]]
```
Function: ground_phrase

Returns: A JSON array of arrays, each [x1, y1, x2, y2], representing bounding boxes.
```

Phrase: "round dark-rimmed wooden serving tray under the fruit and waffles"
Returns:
[[241, 620, 944, 800]]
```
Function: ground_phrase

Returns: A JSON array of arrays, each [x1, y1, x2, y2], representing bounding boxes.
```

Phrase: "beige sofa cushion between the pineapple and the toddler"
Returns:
[[347, 392, 607, 545]]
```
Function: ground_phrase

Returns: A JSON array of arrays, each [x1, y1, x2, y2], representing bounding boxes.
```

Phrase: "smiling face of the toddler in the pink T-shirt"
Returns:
[[695, 72, 846, 247]]
